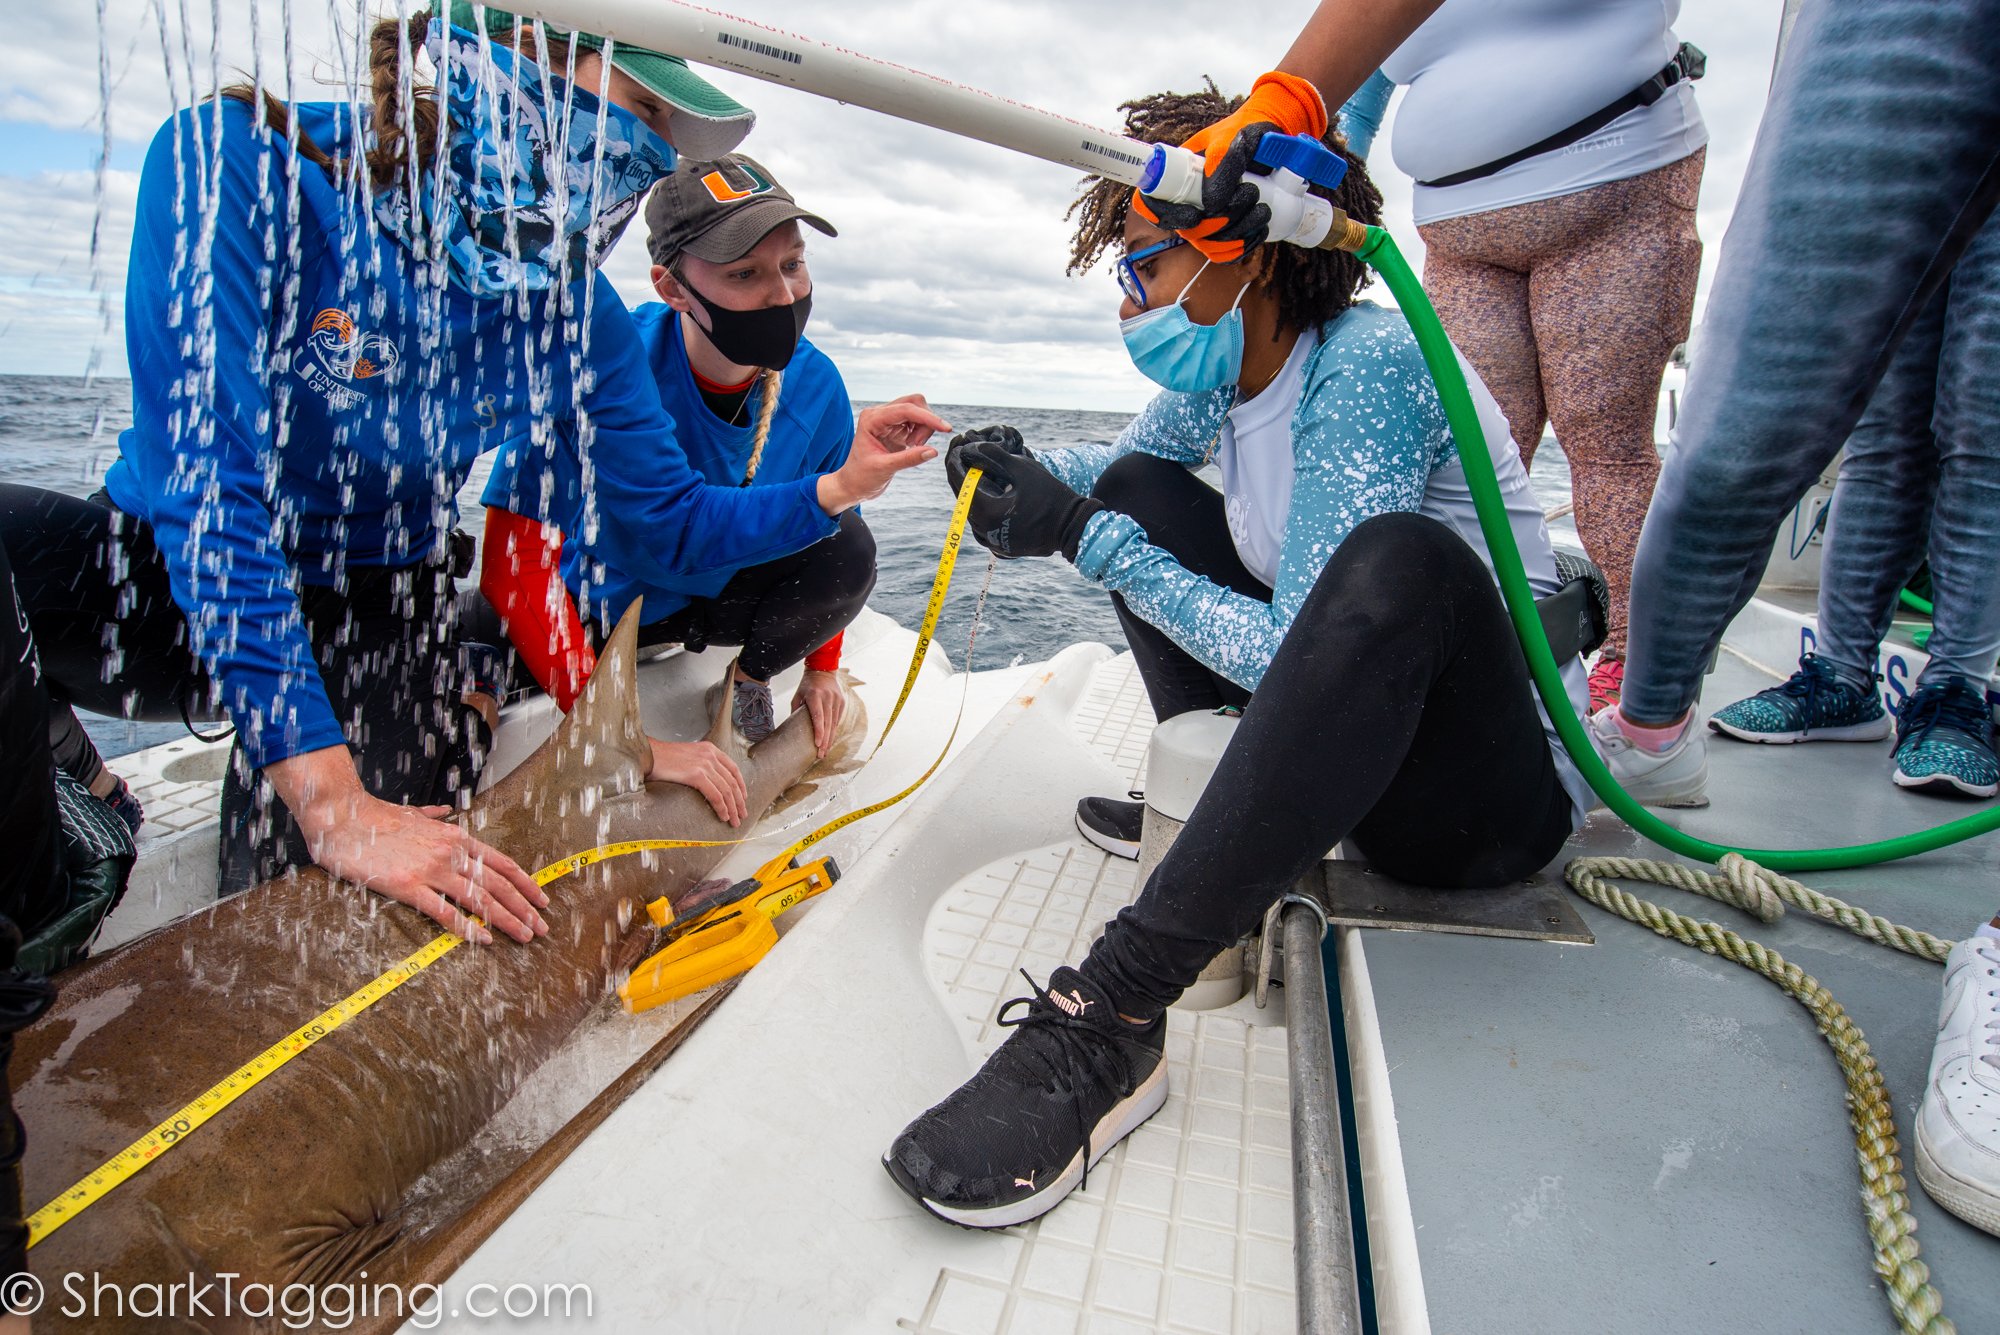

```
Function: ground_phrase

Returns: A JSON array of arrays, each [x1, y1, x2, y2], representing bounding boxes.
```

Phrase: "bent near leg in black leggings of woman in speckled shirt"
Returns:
[[1084, 514, 1572, 1019]]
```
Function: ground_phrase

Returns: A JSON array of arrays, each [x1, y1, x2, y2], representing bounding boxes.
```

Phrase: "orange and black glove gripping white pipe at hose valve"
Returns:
[[1132, 70, 1326, 264]]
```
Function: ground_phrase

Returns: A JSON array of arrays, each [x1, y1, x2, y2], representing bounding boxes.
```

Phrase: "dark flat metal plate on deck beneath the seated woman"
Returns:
[[1300, 861, 1596, 945]]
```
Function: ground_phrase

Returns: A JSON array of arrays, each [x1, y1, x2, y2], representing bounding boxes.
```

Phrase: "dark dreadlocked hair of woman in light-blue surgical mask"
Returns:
[[1062, 78, 1382, 334]]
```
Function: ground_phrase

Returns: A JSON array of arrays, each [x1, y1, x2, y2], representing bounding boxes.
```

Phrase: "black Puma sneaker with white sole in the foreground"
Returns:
[[882, 967, 1166, 1229]]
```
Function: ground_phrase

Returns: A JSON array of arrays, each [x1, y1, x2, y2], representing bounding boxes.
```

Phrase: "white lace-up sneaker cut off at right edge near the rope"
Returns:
[[1916, 935, 2000, 1237]]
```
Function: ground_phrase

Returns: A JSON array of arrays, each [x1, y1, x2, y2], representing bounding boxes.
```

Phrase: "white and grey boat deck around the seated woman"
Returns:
[[74, 595, 2000, 1335]]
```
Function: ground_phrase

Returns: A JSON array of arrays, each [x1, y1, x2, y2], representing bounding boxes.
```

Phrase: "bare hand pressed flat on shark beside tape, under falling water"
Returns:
[[264, 747, 548, 945]]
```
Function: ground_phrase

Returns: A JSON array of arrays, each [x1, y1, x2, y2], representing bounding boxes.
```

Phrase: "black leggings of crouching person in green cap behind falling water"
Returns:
[[0, 486, 474, 893]]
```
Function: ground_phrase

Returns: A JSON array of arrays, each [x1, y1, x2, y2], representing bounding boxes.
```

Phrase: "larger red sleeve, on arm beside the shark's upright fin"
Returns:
[[480, 506, 598, 713]]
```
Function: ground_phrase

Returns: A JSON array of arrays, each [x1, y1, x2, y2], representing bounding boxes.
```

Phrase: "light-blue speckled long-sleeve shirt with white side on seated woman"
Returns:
[[1036, 302, 1596, 821]]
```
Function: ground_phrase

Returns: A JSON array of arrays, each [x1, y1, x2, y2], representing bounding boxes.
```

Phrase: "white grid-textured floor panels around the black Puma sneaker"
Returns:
[[916, 839, 1296, 1335]]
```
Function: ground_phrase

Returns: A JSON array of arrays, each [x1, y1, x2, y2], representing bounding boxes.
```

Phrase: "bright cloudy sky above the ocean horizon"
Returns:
[[0, 0, 1782, 410]]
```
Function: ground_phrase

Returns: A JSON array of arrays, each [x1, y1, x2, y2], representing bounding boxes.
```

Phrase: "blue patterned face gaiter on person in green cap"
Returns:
[[374, 20, 674, 298]]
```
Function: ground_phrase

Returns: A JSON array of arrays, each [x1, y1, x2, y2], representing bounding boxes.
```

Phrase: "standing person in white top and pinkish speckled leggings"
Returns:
[[1340, 0, 1708, 711]]
